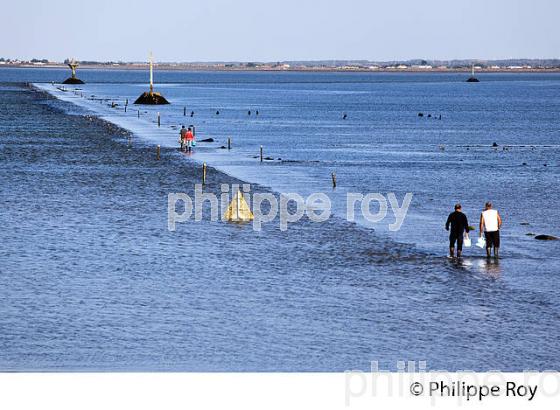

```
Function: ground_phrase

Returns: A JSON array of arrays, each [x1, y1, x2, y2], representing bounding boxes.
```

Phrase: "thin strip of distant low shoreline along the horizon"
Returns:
[[0, 64, 560, 74]]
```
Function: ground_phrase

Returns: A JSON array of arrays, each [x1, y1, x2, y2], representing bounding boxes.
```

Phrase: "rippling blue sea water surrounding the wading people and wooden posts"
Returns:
[[0, 69, 560, 371]]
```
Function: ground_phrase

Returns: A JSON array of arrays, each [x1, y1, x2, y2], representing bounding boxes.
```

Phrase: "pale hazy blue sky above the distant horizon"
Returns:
[[0, 0, 560, 61]]
